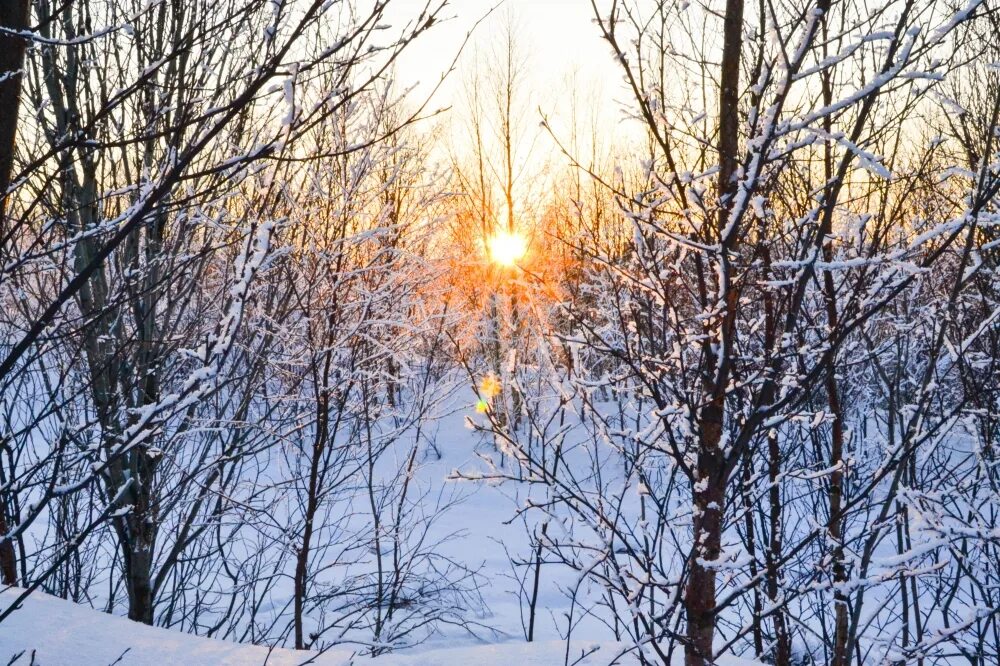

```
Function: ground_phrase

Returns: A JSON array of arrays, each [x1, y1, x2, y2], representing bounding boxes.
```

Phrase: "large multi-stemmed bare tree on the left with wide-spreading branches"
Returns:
[[0, 1, 443, 623]]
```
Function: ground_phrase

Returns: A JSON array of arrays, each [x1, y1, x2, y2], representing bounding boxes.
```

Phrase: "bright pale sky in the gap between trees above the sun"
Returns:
[[378, 0, 639, 244]]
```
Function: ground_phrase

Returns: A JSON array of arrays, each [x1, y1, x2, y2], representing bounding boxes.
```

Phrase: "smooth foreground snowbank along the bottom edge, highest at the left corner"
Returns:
[[0, 589, 751, 666]]
